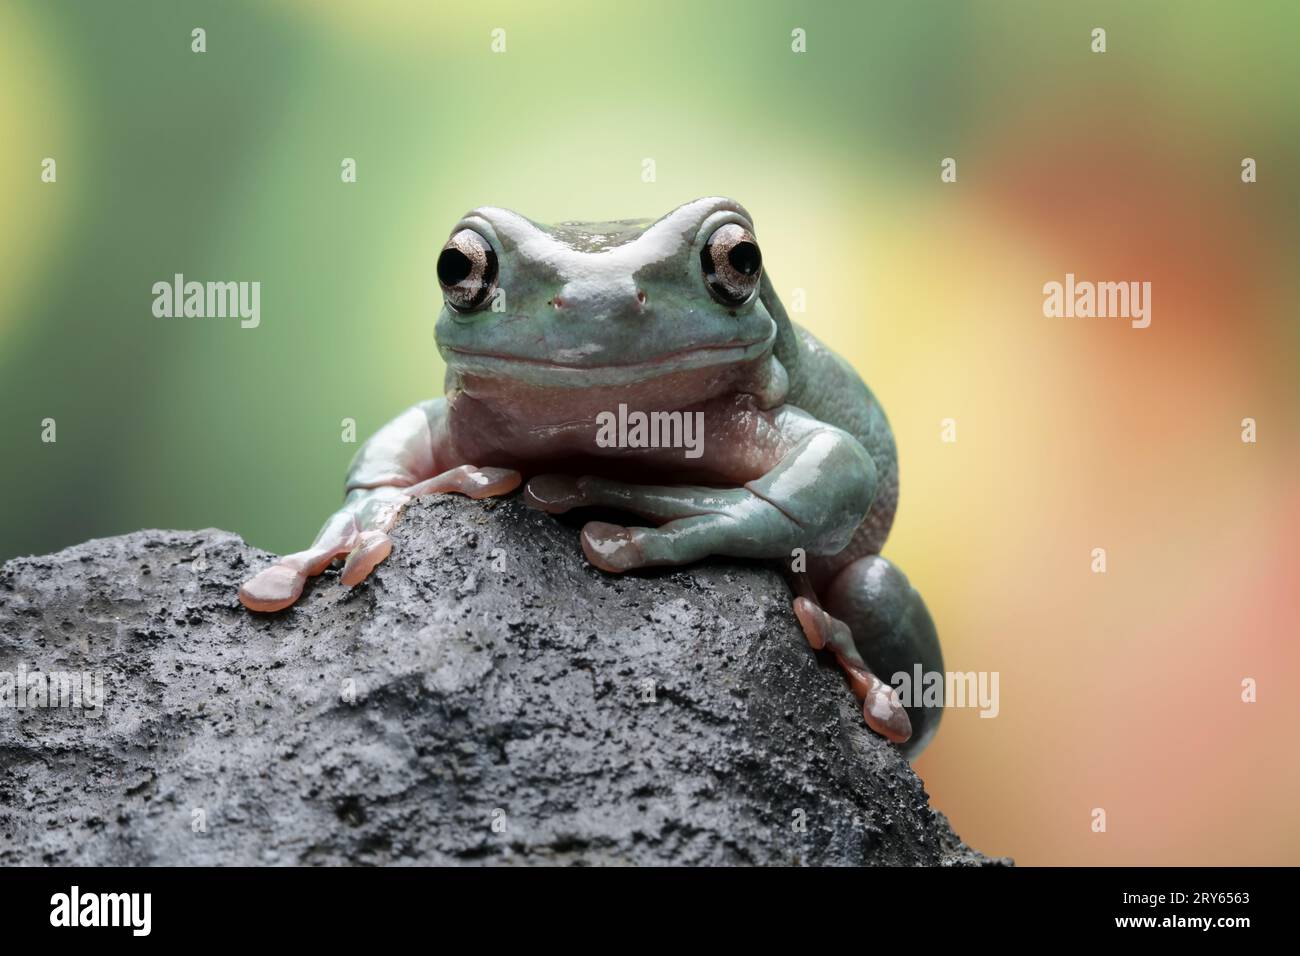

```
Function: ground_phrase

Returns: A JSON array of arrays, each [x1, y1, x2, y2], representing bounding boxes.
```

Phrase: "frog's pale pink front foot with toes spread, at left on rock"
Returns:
[[239, 464, 523, 611]]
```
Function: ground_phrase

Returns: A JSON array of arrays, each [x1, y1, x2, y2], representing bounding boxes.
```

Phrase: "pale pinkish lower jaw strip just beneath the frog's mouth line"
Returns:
[[441, 337, 772, 389]]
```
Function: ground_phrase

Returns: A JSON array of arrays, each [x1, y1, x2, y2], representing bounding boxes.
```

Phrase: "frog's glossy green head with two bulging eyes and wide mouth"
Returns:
[[436, 199, 777, 405]]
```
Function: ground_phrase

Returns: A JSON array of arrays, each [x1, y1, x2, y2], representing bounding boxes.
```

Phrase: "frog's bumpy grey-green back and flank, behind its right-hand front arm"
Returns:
[[787, 324, 898, 566]]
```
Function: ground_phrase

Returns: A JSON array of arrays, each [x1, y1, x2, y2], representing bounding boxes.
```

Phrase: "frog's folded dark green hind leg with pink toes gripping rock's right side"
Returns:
[[794, 554, 944, 757]]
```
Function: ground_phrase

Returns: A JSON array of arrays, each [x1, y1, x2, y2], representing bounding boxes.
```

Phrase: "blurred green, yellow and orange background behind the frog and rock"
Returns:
[[0, 0, 1300, 864]]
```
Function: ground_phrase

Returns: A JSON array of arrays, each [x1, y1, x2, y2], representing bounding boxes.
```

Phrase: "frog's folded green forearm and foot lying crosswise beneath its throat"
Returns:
[[524, 475, 800, 572]]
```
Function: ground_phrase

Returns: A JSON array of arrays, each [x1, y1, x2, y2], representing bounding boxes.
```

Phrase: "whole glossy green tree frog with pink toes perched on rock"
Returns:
[[239, 199, 943, 756]]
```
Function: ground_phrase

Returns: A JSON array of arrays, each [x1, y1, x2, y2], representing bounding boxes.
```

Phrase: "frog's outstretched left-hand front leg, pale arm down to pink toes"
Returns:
[[239, 399, 521, 611]]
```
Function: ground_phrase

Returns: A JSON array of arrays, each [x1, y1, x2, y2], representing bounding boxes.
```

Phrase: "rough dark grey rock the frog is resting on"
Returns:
[[0, 496, 991, 865]]
